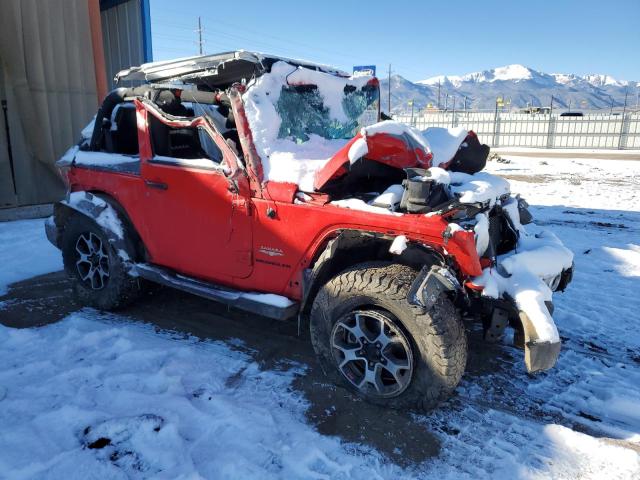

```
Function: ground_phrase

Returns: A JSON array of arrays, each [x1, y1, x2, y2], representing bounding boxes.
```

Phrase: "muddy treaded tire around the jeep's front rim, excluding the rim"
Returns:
[[310, 262, 467, 411]]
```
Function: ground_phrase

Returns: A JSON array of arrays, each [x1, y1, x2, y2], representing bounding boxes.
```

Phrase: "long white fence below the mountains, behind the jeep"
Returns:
[[394, 111, 640, 150]]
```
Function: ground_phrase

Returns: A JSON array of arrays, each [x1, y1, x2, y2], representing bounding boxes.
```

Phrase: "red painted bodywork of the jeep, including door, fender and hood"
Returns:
[[69, 91, 481, 299]]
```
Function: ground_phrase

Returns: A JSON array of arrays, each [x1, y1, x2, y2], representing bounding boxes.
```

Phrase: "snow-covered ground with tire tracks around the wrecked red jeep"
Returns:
[[0, 157, 640, 479]]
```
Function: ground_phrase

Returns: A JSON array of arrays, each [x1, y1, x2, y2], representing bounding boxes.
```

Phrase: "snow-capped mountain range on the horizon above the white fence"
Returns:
[[381, 64, 640, 112]]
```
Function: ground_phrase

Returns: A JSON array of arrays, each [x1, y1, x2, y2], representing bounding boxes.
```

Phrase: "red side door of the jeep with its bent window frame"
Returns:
[[137, 103, 253, 282]]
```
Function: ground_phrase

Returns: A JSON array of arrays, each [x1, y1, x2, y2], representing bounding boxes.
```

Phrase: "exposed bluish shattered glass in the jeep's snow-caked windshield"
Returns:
[[275, 84, 380, 143]]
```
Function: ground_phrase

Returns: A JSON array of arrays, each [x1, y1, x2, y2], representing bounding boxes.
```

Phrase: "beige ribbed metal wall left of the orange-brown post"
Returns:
[[0, 0, 97, 206]]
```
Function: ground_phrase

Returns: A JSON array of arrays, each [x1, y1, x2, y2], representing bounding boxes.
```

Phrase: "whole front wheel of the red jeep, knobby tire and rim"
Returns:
[[311, 263, 467, 410]]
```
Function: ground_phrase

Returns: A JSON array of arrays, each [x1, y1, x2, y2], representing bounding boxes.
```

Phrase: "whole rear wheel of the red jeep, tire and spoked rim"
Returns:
[[62, 214, 140, 310]]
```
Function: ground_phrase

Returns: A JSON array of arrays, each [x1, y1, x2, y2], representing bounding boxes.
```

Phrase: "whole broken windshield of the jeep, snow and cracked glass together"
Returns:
[[242, 61, 380, 192]]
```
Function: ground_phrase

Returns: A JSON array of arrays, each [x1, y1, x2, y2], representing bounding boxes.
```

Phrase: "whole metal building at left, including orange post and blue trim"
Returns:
[[0, 0, 151, 208]]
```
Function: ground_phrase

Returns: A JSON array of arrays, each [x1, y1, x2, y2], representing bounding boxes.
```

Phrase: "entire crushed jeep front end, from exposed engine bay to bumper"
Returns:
[[401, 167, 573, 372]]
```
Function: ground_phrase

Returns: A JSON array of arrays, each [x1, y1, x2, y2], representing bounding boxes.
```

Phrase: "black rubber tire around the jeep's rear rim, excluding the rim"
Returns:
[[62, 214, 141, 310]]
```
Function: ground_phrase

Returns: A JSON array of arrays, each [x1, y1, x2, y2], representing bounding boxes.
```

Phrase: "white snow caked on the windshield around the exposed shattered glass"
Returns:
[[242, 61, 372, 191]]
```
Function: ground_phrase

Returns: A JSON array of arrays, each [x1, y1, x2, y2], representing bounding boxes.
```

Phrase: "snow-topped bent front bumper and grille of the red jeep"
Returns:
[[469, 197, 573, 372]]
